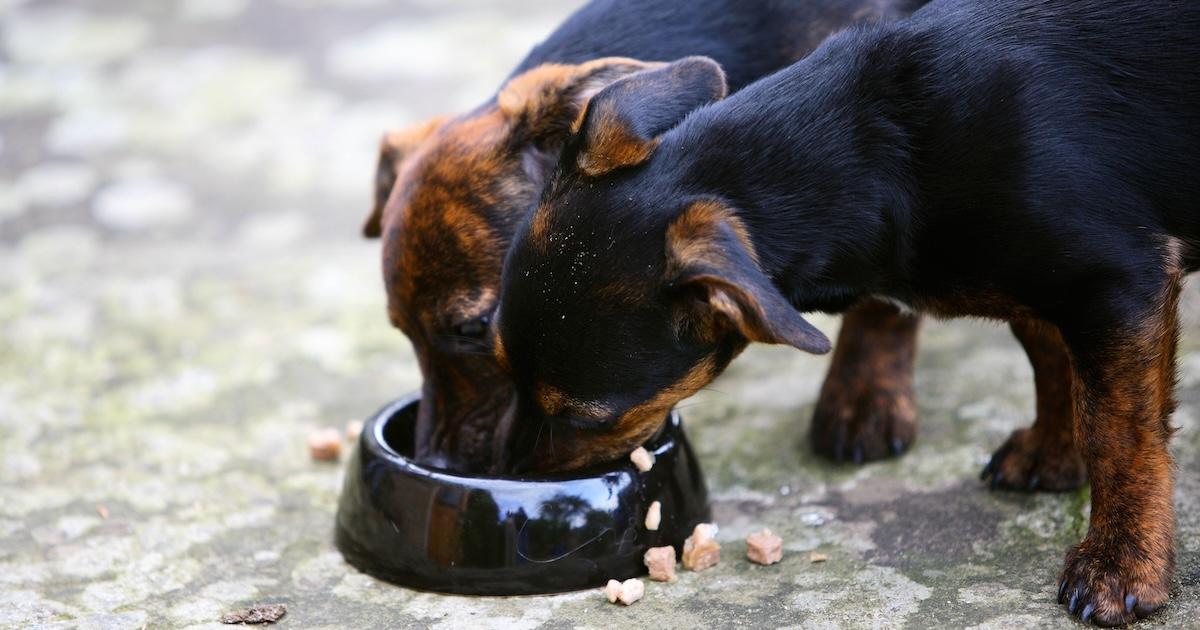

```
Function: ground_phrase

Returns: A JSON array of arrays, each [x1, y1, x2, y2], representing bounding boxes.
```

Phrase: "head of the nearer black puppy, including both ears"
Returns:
[[496, 58, 829, 470]]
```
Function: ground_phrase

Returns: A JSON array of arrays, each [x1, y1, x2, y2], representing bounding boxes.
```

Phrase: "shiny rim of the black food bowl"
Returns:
[[360, 391, 683, 487]]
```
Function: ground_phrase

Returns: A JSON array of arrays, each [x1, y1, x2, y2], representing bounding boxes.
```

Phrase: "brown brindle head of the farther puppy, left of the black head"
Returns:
[[362, 58, 655, 469]]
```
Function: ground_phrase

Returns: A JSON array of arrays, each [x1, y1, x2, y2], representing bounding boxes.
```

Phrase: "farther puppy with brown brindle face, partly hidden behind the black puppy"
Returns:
[[364, 0, 923, 470]]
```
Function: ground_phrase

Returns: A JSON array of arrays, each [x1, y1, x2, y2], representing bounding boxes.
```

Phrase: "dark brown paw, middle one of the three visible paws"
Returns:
[[979, 428, 1087, 492]]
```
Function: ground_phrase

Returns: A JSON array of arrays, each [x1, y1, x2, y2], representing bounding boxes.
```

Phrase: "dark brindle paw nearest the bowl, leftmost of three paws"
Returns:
[[810, 382, 917, 463]]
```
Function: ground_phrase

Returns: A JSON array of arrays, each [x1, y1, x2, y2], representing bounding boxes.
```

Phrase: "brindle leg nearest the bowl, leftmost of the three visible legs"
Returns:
[[809, 300, 920, 463]]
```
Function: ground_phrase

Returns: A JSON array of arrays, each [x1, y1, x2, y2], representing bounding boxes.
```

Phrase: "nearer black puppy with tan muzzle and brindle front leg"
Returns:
[[496, 0, 1200, 624]]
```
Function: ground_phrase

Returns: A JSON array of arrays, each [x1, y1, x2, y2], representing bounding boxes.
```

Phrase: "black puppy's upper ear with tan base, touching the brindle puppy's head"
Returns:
[[576, 56, 726, 176]]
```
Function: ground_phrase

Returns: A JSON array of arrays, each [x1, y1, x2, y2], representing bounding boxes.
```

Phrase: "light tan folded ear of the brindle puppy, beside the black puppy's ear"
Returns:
[[496, 56, 665, 149]]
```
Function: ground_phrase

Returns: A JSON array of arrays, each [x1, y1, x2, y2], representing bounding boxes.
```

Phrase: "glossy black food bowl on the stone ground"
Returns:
[[337, 395, 710, 595]]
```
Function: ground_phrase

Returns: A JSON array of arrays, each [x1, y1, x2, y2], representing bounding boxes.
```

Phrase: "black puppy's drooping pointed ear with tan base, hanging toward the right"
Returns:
[[666, 202, 830, 354]]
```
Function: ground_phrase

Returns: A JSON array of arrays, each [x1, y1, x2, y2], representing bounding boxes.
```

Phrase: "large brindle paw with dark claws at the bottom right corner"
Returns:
[[1058, 540, 1170, 628]]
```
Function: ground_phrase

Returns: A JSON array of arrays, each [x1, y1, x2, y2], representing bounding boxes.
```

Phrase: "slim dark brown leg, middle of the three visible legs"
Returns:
[[980, 318, 1087, 491]]
